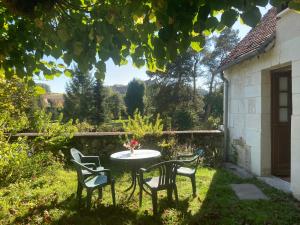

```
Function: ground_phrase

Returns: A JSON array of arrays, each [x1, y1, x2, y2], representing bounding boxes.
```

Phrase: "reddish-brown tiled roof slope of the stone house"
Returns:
[[220, 8, 277, 68]]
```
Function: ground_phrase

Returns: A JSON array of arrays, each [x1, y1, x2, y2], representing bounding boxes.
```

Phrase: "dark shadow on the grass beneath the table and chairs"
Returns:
[[12, 190, 188, 225]]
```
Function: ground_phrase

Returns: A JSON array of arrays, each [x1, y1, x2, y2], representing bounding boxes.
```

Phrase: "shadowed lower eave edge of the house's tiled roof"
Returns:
[[216, 33, 276, 73]]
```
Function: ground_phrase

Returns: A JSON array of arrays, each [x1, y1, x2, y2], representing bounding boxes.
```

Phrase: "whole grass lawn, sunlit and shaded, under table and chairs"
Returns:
[[0, 163, 300, 225]]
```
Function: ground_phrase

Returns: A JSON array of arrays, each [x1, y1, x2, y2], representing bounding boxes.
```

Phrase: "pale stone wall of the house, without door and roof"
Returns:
[[224, 10, 300, 199]]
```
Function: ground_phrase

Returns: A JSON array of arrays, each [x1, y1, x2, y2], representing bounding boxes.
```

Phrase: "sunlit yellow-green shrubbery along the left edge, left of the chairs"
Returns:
[[0, 77, 70, 185]]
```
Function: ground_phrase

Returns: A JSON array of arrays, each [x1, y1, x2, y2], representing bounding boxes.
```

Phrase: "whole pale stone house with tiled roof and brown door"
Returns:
[[219, 8, 300, 199]]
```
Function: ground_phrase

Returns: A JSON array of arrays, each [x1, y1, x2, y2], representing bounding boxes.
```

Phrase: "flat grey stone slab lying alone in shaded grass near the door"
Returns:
[[230, 184, 269, 200]]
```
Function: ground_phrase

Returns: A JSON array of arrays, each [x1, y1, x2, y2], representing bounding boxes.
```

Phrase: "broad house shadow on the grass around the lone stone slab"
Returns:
[[181, 169, 300, 225]]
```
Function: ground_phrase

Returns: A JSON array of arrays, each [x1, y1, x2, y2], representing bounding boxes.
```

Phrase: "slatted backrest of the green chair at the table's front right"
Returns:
[[157, 161, 178, 188]]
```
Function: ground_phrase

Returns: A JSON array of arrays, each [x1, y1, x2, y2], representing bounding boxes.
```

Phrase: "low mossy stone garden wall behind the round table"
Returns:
[[16, 130, 224, 165]]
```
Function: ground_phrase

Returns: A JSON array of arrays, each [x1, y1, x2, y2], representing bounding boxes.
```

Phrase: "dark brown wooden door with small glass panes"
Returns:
[[271, 67, 292, 179]]
